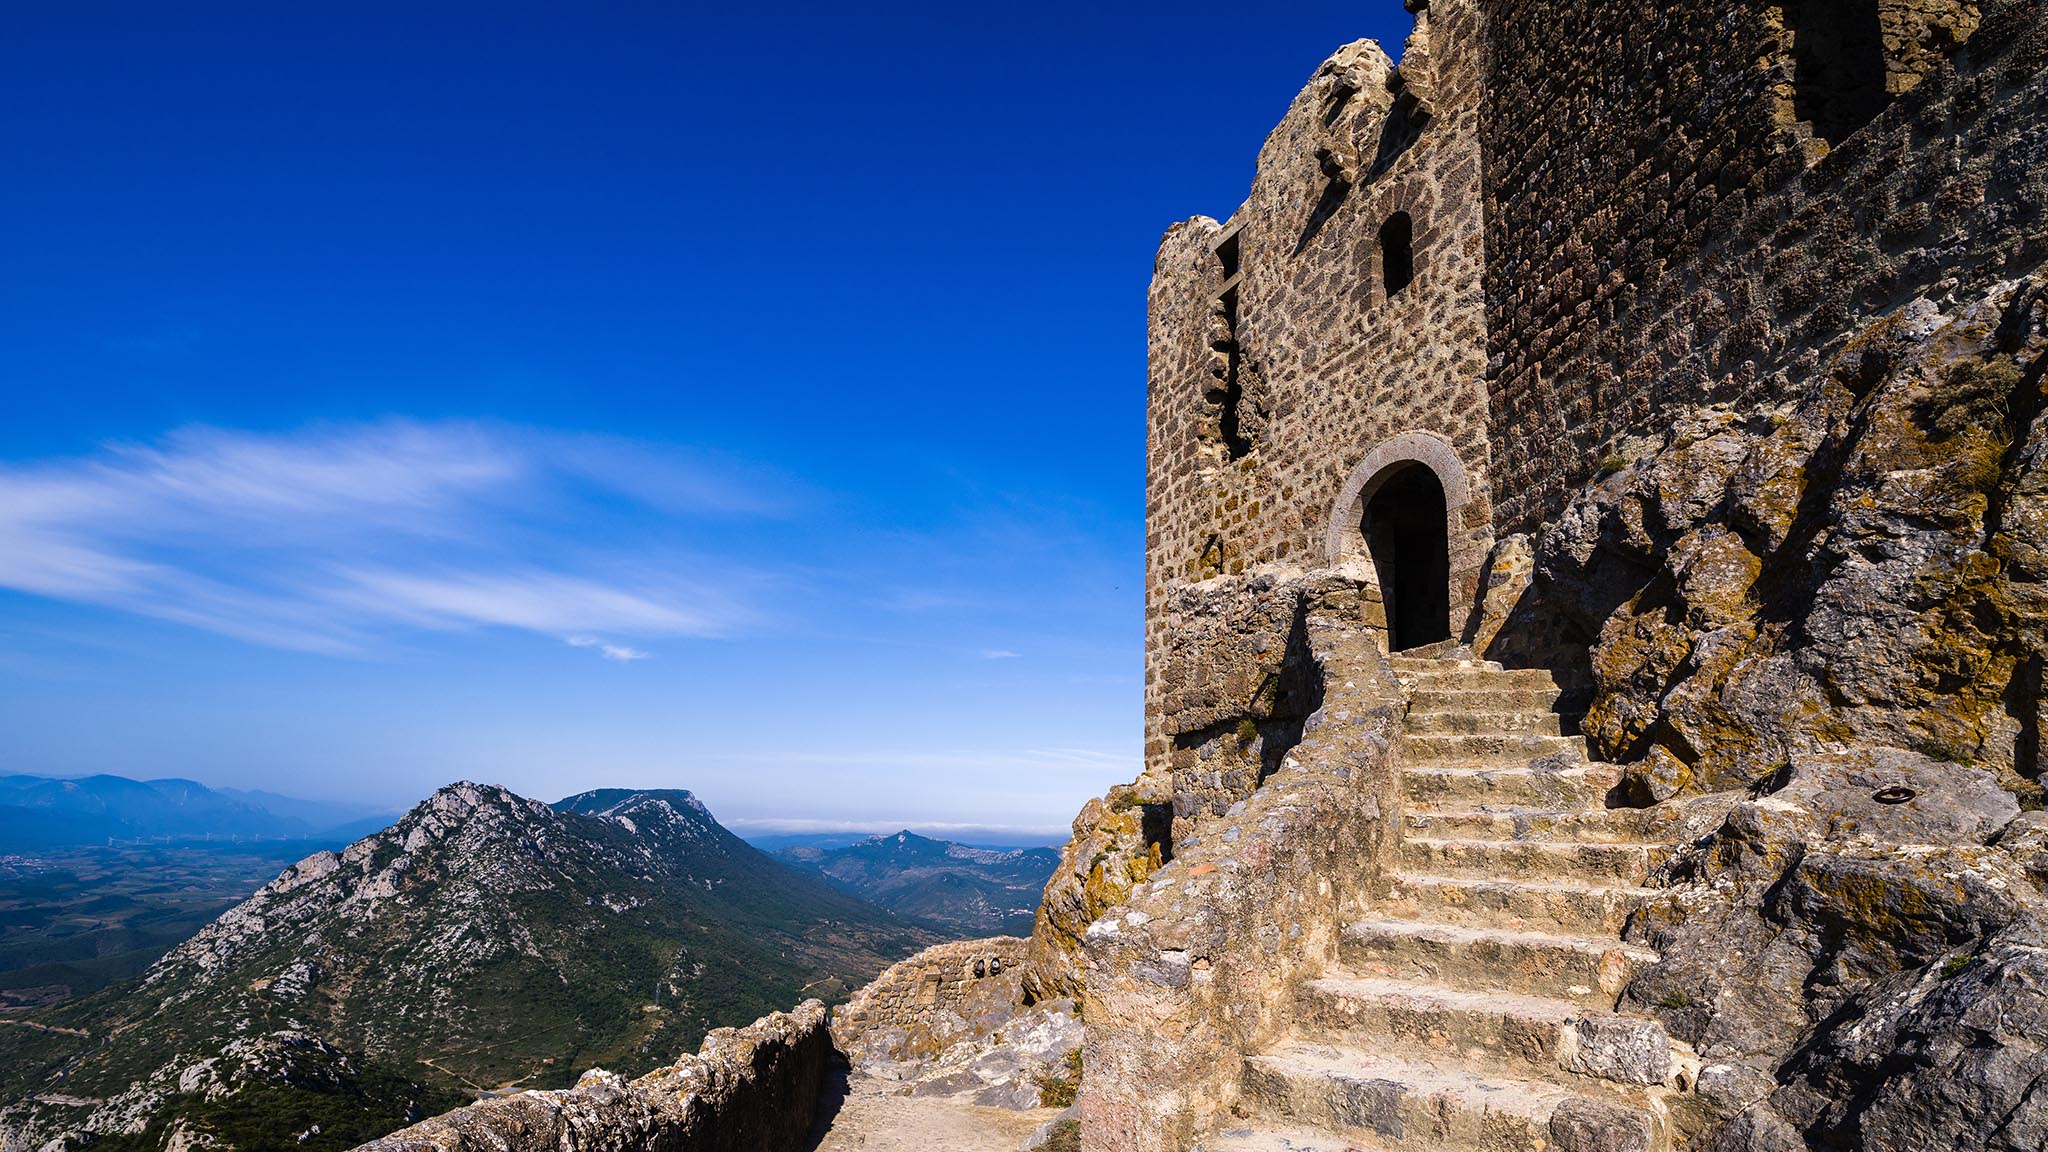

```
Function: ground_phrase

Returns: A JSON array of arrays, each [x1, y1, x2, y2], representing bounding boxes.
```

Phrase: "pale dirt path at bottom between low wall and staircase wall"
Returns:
[[811, 1076, 1059, 1152]]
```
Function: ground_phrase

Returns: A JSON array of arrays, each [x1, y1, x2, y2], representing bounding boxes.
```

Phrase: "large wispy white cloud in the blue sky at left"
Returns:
[[0, 422, 786, 660]]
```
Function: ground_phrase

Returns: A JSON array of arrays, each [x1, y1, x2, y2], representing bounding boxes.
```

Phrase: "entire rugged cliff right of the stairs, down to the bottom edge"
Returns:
[[1493, 277, 2048, 1150]]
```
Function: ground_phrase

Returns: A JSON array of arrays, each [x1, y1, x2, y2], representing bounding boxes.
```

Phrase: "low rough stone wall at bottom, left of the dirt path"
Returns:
[[356, 1000, 831, 1152]]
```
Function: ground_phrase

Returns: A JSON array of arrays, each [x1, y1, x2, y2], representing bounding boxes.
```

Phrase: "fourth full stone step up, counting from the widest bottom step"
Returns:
[[1378, 873, 1657, 937]]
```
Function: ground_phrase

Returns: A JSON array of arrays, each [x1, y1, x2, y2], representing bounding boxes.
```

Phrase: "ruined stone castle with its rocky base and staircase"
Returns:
[[352, 0, 2048, 1152]]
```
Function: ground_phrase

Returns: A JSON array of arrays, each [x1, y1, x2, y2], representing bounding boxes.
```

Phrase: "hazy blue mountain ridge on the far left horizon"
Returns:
[[0, 775, 389, 851]]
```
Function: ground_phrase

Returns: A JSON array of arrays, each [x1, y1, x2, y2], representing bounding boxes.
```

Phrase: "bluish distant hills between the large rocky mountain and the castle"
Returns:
[[776, 828, 1059, 937]]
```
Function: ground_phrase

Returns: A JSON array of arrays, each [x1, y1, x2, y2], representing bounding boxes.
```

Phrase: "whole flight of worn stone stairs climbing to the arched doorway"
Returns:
[[1202, 656, 1690, 1152]]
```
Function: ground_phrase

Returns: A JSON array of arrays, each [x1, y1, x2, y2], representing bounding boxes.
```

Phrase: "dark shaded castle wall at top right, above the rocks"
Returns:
[[1483, 0, 2023, 535]]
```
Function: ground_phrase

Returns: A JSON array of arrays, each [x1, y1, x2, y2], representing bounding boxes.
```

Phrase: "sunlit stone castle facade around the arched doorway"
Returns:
[[1145, 0, 1491, 773]]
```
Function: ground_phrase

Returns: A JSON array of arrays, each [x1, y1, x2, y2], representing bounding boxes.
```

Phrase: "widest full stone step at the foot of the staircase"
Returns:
[[1243, 1041, 1655, 1152]]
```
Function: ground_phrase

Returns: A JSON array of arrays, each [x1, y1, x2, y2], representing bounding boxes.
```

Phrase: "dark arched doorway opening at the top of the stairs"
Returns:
[[1360, 463, 1450, 652]]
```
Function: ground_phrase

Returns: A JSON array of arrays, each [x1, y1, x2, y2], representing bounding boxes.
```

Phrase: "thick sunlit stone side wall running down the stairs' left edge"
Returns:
[[1079, 570, 1405, 1152]]
